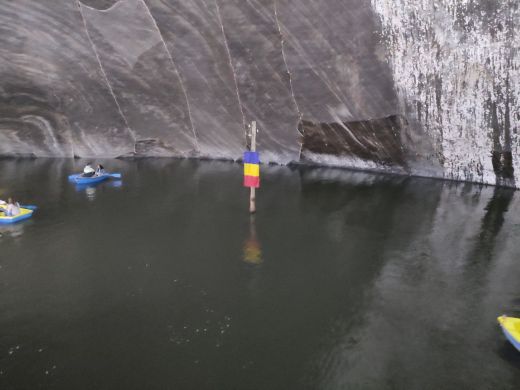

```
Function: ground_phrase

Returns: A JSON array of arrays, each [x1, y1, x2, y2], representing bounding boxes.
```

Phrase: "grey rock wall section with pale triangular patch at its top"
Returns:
[[80, 0, 198, 156]]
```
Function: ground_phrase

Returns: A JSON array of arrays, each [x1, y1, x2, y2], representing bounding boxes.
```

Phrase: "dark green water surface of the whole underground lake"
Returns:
[[0, 160, 520, 390]]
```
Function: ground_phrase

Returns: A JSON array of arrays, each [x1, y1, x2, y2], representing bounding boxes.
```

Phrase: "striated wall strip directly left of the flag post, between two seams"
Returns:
[[145, 0, 244, 159]]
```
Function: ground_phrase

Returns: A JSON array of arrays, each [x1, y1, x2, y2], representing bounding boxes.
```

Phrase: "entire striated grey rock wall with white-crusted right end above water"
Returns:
[[0, 0, 520, 187]]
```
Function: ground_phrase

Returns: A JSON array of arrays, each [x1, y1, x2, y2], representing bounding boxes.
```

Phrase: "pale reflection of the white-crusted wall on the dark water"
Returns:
[[311, 184, 520, 389]]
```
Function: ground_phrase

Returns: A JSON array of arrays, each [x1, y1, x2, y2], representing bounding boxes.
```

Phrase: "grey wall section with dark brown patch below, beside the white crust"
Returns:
[[277, 0, 422, 172]]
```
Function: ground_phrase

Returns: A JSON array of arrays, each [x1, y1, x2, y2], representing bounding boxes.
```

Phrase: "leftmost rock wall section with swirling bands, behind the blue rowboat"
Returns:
[[0, 0, 134, 157]]
